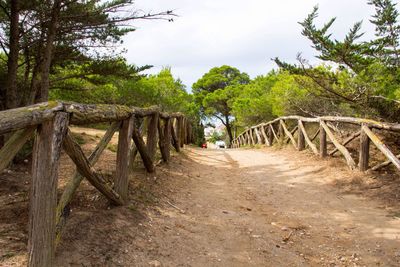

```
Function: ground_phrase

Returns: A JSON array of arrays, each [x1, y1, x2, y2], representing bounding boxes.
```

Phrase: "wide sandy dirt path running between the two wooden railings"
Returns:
[[54, 149, 400, 266]]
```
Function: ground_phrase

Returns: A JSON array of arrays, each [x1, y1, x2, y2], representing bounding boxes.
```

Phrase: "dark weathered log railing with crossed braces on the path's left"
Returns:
[[0, 102, 193, 266]]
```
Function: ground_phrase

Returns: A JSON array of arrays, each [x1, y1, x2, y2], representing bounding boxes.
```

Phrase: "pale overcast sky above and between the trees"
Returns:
[[123, 0, 373, 90]]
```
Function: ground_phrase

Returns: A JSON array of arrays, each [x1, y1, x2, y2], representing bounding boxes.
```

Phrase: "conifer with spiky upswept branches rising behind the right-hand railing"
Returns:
[[275, 0, 400, 120]]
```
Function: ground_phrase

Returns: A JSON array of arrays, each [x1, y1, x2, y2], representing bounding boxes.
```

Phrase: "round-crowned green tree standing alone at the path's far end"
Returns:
[[192, 65, 250, 142]]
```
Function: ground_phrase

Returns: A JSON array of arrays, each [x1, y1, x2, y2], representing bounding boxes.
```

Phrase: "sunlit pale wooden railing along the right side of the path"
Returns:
[[231, 116, 400, 171]]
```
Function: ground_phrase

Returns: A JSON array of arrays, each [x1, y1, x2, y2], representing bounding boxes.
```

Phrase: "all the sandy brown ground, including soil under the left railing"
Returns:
[[0, 129, 400, 266]]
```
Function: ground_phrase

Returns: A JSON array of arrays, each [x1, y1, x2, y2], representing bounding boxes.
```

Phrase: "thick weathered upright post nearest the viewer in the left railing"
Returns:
[[28, 112, 69, 267]]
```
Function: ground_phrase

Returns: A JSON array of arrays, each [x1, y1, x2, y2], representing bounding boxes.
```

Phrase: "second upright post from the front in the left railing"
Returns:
[[114, 115, 135, 201]]
